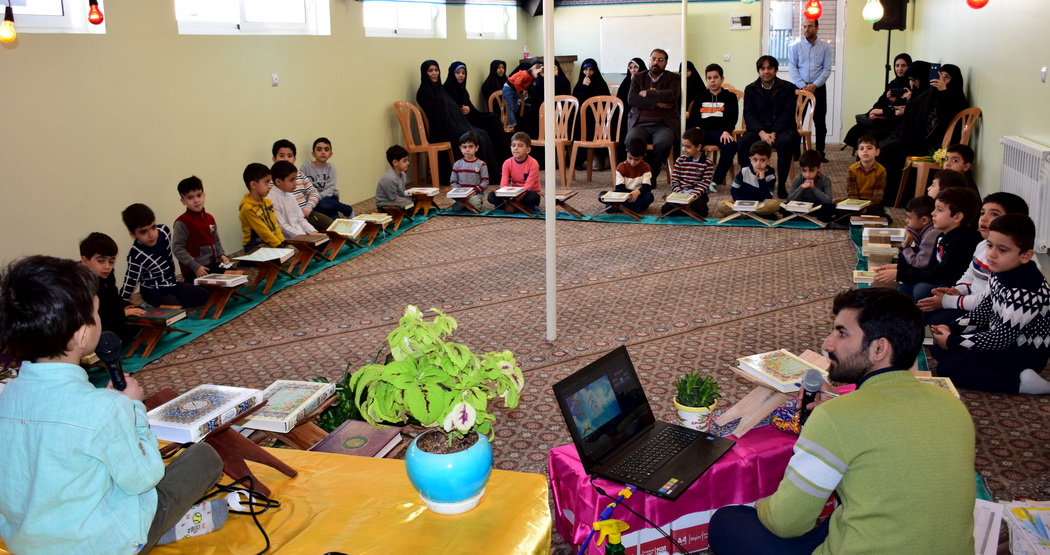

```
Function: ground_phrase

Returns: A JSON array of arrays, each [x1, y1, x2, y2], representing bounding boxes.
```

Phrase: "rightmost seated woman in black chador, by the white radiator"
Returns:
[[879, 62, 970, 198]]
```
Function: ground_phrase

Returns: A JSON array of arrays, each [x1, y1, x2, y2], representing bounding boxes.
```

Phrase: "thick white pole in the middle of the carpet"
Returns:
[[543, 0, 554, 341]]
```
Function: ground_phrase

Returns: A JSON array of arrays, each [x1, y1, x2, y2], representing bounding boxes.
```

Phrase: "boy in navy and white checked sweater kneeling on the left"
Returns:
[[121, 204, 210, 307]]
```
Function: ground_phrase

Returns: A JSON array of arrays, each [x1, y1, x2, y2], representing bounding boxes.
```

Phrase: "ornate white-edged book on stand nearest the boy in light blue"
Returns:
[[146, 384, 263, 443]]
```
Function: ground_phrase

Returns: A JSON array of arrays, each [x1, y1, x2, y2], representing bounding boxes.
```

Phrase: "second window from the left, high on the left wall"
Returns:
[[175, 0, 332, 35]]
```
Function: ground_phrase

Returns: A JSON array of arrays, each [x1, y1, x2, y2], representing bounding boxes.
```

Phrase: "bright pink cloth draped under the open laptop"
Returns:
[[548, 426, 797, 555]]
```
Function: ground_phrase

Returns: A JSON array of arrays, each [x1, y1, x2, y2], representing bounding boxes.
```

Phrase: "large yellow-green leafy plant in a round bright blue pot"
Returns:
[[348, 305, 525, 514]]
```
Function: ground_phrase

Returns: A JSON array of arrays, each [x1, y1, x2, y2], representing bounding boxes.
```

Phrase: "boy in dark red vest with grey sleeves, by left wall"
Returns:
[[171, 175, 230, 283]]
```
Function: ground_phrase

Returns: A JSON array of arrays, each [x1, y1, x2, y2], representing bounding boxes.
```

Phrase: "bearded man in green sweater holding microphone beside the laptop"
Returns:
[[709, 287, 975, 555]]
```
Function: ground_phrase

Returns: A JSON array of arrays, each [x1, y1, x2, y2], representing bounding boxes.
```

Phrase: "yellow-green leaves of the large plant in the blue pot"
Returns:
[[348, 304, 525, 445]]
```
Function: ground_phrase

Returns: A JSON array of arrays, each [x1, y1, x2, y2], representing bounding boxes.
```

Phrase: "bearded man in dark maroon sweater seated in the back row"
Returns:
[[626, 48, 681, 180]]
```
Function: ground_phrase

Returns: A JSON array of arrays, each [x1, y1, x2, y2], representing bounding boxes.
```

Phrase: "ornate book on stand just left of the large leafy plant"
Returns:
[[240, 380, 335, 433]]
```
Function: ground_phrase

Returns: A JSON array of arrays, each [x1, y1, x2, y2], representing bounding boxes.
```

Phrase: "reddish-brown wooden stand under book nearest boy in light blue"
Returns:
[[143, 388, 298, 495]]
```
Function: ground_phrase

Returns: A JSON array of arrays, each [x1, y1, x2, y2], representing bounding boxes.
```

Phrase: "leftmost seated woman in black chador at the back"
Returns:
[[416, 60, 503, 185]]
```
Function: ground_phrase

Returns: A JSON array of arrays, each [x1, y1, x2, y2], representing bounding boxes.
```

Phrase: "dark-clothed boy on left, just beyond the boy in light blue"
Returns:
[[80, 232, 146, 345]]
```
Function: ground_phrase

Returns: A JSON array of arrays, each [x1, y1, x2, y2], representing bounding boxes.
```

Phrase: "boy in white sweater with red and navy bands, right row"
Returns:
[[919, 192, 1038, 324]]
